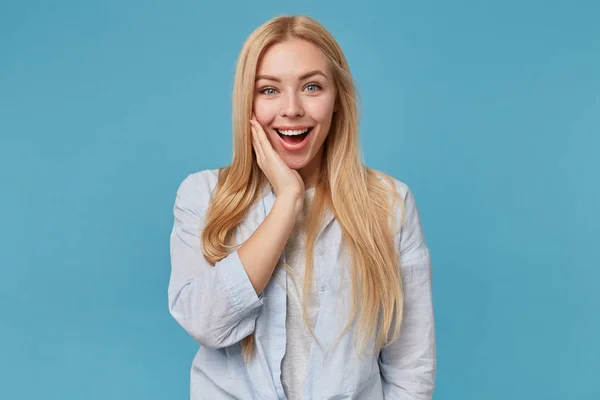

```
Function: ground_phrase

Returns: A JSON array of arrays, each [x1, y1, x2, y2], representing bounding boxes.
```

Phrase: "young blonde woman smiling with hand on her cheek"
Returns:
[[168, 16, 436, 400]]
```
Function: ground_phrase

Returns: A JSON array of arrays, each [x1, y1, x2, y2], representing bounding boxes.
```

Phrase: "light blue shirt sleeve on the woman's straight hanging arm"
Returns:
[[379, 189, 436, 400]]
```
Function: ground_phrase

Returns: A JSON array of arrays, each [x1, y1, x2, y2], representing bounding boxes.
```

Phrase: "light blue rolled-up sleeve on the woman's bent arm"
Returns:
[[168, 172, 263, 348]]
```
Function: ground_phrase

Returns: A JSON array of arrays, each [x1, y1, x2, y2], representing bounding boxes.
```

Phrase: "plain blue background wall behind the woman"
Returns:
[[0, 0, 600, 400]]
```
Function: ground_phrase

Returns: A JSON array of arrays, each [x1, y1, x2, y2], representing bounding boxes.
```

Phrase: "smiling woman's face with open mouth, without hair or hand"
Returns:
[[253, 39, 336, 183]]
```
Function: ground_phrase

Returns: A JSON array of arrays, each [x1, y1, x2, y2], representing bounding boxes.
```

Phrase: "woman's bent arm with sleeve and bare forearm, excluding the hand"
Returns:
[[168, 171, 295, 348]]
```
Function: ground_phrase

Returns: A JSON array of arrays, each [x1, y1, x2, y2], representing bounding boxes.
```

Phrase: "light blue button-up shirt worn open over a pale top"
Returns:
[[168, 170, 436, 400]]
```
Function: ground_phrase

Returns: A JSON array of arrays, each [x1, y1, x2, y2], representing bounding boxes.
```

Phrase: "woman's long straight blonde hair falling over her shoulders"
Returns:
[[202, 16, 403, 361]]
